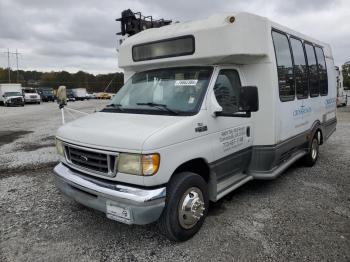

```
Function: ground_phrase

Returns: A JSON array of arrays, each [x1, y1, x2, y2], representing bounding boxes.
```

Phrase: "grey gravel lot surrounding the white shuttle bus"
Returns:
[[0, 100, 350, 261]]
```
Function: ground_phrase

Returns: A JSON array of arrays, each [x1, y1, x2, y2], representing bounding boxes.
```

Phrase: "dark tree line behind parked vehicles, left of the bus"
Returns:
[[0, 67, 124, 93]]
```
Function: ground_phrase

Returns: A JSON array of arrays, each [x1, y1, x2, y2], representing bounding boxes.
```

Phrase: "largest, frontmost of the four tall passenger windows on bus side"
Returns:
[[272, 31, 295, 102]]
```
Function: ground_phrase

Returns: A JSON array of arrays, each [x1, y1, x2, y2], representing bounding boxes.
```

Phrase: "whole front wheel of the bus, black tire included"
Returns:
[[158, 172, 209, 241]]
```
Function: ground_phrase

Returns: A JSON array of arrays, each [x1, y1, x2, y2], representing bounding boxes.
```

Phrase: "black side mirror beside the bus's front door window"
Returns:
[[239, 86, 259, 112]]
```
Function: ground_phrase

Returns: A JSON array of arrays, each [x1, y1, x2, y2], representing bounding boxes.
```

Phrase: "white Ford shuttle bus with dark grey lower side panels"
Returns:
[[54, 13, 337, 241]]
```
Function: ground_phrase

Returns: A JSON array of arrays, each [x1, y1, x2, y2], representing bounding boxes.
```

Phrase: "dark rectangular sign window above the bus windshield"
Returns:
[[132, 36, 195, 61]]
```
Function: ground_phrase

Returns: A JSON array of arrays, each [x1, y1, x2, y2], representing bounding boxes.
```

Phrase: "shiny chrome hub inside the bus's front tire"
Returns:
[[179, 187, 205, 229]]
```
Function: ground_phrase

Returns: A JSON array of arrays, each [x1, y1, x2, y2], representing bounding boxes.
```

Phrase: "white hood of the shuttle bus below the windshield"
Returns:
[[57, 112, 183, 152]]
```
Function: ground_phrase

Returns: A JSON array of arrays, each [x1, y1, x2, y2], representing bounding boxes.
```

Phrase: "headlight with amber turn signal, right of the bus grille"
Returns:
[[118, 153, 160, 176]]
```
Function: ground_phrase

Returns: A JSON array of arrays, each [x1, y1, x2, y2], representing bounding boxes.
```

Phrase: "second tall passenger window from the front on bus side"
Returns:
[[290, 38, 309, 99]]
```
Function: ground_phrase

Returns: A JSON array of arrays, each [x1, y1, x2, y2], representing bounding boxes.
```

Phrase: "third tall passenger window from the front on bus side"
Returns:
[[305, 44, 320, 97]]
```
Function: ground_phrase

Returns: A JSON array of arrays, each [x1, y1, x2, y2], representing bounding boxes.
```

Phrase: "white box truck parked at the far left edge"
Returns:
[[0, 84, 24, 106]]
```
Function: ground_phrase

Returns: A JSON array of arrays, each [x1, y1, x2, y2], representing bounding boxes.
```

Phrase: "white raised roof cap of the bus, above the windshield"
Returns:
[[119, 12, 332, 71]]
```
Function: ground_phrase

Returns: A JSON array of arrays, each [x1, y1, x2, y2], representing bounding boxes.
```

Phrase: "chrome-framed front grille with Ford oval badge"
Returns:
[[64, 144, 118, 177]]
